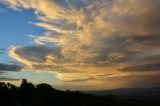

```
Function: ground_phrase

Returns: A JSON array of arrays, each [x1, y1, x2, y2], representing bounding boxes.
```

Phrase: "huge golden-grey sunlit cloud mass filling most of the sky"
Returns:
[[1, 0, 160, 88]]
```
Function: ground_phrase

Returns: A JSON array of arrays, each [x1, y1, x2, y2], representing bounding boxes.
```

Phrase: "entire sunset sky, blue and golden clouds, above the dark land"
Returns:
[[0, 0, 160, 90]]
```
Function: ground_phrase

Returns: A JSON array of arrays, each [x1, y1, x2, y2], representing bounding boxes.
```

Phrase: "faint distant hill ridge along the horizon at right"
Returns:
[[84, 87, 160, 97]]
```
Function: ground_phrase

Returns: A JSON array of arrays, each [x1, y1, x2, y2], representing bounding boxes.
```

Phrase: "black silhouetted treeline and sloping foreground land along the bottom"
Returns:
[[0, 79, 160, 106]]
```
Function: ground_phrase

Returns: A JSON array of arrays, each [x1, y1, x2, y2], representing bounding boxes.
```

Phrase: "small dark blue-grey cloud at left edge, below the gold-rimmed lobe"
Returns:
[[0, 63, 23, 71]]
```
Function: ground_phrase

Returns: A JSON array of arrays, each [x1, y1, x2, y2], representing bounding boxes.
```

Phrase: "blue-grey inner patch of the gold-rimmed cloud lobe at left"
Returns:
[[11, 46, 61, 63]]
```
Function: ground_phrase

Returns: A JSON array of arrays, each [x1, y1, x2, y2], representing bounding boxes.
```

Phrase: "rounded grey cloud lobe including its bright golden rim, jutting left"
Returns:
[[9, 45, 63, 67]]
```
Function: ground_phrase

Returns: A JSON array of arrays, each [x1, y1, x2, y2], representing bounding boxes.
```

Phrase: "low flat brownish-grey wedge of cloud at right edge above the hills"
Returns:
[[121, 63, 160, 72]]
